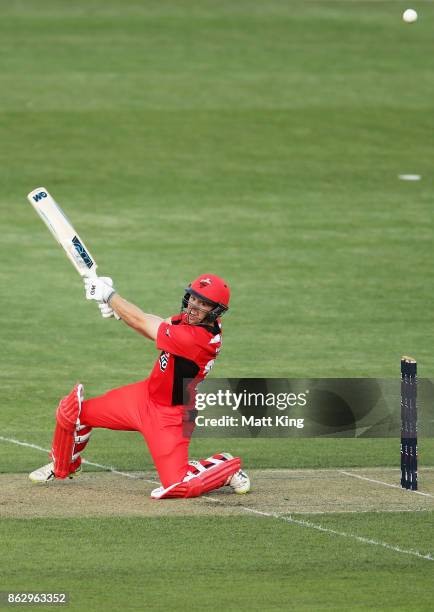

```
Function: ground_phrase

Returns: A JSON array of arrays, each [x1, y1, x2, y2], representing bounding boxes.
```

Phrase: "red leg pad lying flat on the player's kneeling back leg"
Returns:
[[153, 457, 241, 499]]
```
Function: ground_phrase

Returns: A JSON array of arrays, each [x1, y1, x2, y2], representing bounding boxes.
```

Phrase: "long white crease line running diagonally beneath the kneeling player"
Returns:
[[0, 436, 434, 561]]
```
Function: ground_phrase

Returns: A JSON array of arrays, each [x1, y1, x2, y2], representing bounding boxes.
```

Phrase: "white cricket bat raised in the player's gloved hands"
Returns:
[[27, 187, 97, 278]]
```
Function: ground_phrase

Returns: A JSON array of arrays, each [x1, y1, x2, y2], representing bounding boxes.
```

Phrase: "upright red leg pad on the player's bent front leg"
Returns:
[[51, 385, 80, 478]]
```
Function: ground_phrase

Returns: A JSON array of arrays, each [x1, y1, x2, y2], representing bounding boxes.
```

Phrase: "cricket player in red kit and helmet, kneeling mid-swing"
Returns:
[[29, 274, 250, 499]]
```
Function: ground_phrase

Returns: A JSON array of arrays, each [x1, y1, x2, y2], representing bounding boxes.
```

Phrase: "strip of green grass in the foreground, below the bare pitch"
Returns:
[[1, 514, 432, 610]]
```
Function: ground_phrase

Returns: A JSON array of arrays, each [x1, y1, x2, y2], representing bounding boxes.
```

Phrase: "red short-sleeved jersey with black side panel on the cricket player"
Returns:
[[148, 313, 222, 406]]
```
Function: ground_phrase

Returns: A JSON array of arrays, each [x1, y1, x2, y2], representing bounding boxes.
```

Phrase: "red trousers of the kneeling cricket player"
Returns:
[[80, 380, 190, 487]]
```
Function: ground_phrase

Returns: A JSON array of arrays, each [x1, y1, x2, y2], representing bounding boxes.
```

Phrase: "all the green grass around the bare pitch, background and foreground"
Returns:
[[0, 0, 434, 610]]
